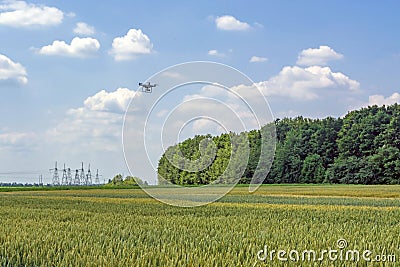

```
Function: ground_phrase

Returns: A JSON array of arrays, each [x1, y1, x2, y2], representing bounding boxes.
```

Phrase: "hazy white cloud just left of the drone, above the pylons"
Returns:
[[47, 88, 135, 151]]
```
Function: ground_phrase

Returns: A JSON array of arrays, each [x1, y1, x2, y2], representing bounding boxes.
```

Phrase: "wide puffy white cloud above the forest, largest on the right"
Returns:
[[236, 66, 360, 100]]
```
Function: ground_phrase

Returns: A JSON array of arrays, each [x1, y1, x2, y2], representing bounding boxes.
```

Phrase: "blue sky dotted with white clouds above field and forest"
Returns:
[[0, 0, 400, 183]]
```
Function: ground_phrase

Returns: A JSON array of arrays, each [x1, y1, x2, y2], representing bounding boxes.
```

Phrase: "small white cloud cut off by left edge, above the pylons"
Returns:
[[0, 54, 28, 84]]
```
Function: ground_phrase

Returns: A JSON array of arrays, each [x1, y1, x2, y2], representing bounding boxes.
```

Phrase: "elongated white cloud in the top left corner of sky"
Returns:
[[0, 1, 64, 27]]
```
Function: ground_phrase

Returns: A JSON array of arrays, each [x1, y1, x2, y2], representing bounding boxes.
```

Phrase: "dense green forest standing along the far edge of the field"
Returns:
[[158, 104, 400, 185]]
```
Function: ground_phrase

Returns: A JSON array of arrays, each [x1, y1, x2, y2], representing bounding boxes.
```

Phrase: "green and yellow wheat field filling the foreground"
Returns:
[[0, 185, 400, 266]]
